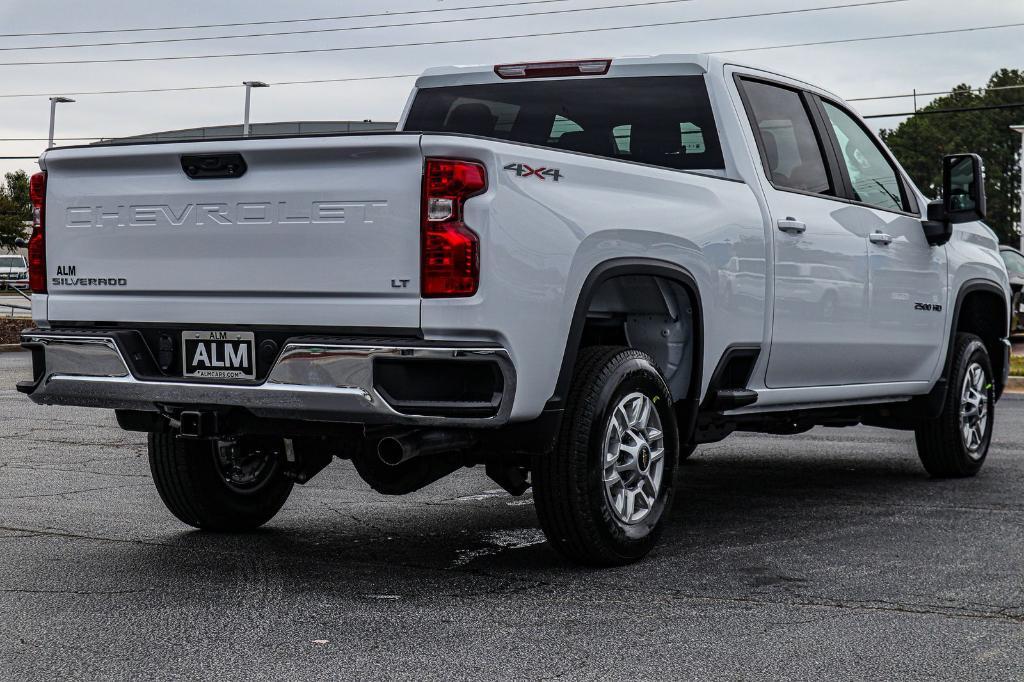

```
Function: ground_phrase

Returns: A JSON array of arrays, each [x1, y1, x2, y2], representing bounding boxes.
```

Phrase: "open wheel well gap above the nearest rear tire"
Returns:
[[579, 274, 697, 401]]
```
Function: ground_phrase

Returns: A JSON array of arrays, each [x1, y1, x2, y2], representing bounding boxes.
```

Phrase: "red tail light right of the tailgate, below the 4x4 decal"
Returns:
[[421, 159, 487, 298]]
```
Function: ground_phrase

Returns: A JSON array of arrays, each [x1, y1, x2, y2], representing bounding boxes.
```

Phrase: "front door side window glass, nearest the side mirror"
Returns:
[[821, 99, 907, 211]]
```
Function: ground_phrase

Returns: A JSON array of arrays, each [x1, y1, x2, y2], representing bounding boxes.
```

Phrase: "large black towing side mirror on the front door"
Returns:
[[925, 154, 987, 246]]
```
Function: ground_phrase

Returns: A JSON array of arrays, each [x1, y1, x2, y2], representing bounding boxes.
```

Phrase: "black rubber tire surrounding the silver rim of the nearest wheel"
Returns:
[[531, 346, 679, 566]]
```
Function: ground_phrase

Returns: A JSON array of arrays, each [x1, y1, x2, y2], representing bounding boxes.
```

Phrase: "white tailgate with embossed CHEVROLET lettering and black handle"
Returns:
[[43, 134, 423, 329]]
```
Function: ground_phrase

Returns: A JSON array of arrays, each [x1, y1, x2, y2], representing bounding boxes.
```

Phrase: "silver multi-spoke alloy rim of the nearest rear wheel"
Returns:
[[603, 393, 665, 525]]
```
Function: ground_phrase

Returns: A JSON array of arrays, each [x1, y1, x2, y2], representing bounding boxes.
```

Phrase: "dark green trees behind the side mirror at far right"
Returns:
[[882, 69, 1024, 244]]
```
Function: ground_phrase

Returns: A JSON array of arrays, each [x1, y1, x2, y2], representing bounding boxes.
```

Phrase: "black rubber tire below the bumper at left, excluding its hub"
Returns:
[[148, 433, 292, 532]]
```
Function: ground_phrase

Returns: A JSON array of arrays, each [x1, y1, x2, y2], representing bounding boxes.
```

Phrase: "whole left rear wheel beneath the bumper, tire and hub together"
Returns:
[[148, 433, 292, 531]]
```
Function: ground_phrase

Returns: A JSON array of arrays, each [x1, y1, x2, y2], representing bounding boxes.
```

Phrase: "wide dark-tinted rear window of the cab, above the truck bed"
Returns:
[[404, 76, 725, 170]]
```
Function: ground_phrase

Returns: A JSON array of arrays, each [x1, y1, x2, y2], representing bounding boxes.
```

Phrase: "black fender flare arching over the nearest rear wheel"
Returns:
[[545, 258, 705, 417]]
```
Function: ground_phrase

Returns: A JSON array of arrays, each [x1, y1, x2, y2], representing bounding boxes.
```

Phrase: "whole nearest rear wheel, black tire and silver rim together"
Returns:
[[532, 347, 679, 565]]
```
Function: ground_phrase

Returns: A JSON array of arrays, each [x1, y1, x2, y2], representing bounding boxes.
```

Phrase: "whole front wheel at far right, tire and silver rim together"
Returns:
[[915, 334, 995, 478]]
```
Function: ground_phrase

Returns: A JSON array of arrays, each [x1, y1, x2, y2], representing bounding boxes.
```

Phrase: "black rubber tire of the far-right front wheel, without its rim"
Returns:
[[914, 334, 995, 478]]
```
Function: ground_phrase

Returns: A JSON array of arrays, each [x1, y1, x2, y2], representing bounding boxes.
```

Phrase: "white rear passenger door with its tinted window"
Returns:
[[739, 78, 874, 388]]
